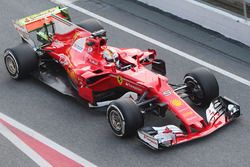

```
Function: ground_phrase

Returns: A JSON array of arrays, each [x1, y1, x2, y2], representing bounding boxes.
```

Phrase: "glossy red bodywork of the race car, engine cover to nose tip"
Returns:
[[40, 22, 232, 144]]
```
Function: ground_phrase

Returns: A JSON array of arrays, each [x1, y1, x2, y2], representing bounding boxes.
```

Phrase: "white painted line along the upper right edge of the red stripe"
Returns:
[[0, 112, 96, 167]]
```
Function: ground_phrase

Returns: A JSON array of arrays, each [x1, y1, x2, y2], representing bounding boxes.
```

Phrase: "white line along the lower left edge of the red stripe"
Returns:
[[0, 123, 52, 167]]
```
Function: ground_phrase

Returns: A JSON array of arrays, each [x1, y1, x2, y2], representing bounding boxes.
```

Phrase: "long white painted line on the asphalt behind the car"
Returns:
[[51, 0, 250, 86]]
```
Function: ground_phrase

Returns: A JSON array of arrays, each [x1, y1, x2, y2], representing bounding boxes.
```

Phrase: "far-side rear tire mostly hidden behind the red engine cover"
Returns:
[[78, 19, 104, 33]]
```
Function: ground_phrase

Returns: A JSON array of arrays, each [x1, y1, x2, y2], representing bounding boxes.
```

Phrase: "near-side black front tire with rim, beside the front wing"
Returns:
[[107, 98, 144, 137]]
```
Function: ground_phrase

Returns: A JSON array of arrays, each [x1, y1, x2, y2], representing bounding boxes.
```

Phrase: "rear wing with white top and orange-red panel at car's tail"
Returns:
[[13, 6, 70, 47]]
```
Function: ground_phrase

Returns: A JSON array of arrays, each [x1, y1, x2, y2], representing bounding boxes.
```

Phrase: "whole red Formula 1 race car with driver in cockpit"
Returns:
[[4, 7, 240, 149]]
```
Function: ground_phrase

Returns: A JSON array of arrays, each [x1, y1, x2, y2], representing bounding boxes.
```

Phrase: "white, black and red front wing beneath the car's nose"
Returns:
[[138, 97, 240, 149]]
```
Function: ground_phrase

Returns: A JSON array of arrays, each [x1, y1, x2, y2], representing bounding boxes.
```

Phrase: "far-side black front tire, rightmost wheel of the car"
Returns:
[[184, 68, 219, 106]]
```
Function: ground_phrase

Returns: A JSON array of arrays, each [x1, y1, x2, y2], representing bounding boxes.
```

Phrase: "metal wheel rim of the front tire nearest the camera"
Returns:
[[109, 110, 123, 131]]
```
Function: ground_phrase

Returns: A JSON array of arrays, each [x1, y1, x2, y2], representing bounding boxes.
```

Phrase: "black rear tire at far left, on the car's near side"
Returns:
[[4, 43, 39, 80]]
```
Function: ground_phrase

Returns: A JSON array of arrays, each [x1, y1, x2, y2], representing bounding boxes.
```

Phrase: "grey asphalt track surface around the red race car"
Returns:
[[0, 0, 250, 167]]
